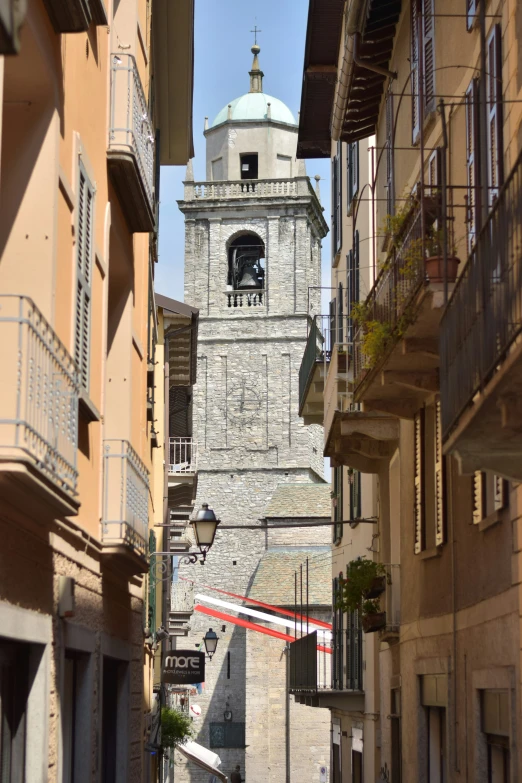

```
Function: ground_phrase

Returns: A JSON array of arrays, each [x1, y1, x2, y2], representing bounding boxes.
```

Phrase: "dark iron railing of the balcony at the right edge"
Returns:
[[440, 148, 522, 439]]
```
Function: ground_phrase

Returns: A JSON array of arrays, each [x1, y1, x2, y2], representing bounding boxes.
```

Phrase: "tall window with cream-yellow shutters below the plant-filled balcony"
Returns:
[[414, 400, 445, 554]]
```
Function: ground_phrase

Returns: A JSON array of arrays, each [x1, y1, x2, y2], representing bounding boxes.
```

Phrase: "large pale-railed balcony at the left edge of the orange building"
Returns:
[[0, 294, 80, 518]]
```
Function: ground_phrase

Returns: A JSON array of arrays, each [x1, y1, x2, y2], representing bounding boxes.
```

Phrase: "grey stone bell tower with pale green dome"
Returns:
[[176, 45, 327, 783]]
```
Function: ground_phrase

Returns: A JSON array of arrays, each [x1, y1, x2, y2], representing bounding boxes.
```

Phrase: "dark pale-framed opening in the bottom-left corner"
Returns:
[[0, 641, 29, 783]]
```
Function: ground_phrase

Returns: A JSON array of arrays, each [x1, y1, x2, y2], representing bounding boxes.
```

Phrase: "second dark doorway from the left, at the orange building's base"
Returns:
[[62, 650, 90, 783]]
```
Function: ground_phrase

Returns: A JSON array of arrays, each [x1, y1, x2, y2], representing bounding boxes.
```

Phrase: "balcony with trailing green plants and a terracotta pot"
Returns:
[[353, 202, 454, 418]]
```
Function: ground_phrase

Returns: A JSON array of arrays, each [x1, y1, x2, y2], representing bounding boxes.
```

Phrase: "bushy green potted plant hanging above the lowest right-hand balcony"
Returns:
[[337, 557, 386, 633]]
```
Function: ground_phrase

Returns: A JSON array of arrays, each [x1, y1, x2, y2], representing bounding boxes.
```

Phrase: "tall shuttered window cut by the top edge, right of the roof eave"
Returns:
[[411, 0, 435, 142]]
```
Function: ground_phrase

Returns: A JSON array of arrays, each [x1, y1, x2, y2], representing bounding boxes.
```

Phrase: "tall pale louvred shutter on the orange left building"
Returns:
[[74, 163, 94, 391]]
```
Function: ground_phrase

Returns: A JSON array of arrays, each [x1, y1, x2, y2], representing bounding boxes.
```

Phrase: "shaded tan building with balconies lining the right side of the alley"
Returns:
[[292, 0, 521, 783]]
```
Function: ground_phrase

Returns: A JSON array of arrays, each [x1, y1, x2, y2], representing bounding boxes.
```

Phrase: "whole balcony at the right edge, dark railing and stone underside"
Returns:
[[440, 147, 522, 481]]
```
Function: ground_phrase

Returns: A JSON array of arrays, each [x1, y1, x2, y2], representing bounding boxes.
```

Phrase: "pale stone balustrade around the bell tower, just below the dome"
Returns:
[[184, 177, 317, 201]]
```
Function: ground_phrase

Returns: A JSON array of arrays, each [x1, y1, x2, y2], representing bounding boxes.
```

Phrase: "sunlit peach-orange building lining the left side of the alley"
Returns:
[[0, 0, 193, 783]]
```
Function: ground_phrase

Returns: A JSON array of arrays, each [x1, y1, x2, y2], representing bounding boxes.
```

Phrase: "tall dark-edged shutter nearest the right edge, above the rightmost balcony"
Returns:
[[486, 24, 504, 206]]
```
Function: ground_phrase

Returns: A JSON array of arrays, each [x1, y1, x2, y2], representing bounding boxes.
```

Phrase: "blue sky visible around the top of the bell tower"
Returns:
[[155, 0, 330, 304]]
